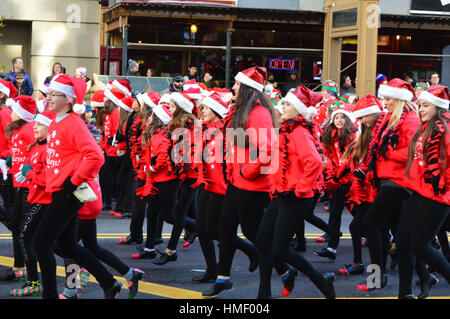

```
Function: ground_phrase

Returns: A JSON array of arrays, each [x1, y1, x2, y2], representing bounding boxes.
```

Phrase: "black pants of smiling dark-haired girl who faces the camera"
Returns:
[[328, 184, 350, 249]]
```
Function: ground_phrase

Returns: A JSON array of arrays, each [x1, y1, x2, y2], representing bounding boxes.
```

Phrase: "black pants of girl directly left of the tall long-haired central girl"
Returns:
[[195, 190, 256, 274]]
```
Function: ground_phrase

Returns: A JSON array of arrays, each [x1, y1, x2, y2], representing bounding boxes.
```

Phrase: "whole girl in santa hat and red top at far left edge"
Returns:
[[0, 96, 36, 280]]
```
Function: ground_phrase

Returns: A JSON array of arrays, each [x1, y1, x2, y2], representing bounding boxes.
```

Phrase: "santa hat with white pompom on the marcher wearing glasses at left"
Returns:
[[49, 74, 87, 114]]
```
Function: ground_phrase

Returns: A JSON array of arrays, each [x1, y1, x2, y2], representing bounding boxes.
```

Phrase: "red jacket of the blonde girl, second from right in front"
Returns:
[[376, 111, 420, 187]]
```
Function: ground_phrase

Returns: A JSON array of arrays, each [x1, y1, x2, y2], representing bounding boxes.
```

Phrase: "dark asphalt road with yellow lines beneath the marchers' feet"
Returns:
[[0, 204, 450, 299]]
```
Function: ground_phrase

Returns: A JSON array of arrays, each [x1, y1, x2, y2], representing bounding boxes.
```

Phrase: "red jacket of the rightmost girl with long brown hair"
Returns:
[[404, 119, 450, 205]]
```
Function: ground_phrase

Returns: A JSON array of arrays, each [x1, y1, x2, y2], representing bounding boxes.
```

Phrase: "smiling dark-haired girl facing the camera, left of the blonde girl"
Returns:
[[314, 108, 356, 260]]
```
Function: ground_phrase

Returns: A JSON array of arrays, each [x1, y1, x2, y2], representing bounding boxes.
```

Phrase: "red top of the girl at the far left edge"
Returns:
[[2, 121, 36, 188]]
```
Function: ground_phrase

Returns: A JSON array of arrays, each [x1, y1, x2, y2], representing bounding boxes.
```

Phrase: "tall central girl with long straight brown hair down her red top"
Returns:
[[203, 67, 278, 297]]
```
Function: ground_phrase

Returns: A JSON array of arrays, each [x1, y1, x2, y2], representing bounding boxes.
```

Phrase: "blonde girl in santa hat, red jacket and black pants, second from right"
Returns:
[[357, 78, 420, 291]]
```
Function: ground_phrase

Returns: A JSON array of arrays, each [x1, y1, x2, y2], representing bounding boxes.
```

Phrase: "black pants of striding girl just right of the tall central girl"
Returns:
[[256, 198, 326, 297]]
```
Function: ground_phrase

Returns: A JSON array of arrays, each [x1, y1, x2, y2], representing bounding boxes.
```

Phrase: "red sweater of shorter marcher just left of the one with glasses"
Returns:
[[27, 141, 52, 204]]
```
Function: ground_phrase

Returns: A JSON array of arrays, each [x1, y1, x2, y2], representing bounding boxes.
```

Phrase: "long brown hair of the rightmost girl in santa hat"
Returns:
[[406, 108, 448, 176]]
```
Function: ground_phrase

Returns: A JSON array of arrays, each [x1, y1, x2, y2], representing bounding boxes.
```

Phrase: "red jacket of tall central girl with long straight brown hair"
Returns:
[[225, 104, 277, 192]]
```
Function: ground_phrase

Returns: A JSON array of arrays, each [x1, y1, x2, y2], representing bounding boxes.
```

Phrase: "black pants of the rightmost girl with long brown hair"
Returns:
[[397, 193, 450, 296]]
